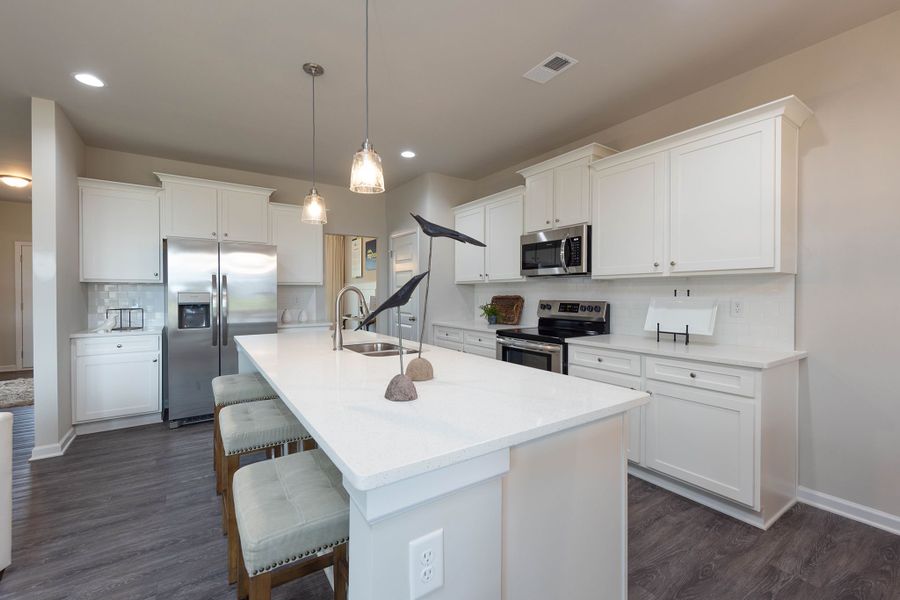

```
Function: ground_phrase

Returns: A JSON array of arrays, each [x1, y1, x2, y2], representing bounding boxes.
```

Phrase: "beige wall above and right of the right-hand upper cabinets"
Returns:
[[475, 12, 900, 515]]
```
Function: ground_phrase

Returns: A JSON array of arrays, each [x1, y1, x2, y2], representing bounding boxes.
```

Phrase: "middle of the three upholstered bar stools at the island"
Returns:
[[219, 398, 312, 583]]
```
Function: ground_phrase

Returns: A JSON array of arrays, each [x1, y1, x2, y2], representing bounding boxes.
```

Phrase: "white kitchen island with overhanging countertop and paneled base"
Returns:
[[235, 331, 648, 600]]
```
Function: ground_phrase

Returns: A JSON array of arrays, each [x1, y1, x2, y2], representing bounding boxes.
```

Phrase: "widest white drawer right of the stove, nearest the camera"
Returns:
[[644, 357, 756, 397]]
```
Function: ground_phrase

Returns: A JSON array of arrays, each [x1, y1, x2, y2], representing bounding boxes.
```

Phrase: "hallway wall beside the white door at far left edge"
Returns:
[[0, 201, 31, 367]]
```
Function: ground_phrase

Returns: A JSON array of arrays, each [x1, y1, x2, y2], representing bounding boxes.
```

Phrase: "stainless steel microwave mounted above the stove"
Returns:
[[520, 225, 591, 277]]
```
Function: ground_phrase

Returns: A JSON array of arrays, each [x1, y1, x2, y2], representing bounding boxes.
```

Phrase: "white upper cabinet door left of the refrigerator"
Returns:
[[80, 188, 162, 282]]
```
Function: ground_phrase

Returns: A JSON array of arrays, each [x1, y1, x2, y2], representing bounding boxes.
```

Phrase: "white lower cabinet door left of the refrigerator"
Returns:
[[74, 352, 162, 423]]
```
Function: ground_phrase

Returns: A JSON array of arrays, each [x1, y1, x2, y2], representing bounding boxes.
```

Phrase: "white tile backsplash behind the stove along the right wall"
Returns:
[[474, 275, 795, 350]]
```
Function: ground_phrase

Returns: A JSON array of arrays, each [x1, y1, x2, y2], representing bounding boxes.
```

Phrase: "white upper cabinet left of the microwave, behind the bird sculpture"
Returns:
[[454, 186, 525, 283]]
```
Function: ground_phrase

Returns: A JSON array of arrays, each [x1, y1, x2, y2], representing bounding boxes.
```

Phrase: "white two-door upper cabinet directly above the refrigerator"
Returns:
[[156, 173, 275, 244]]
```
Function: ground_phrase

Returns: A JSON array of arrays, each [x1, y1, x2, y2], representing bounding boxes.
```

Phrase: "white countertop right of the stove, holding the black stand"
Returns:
[[566, 335, 806, 369]]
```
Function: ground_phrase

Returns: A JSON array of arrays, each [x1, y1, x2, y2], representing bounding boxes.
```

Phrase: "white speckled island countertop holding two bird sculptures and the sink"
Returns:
[[235, 330, 649, 491]]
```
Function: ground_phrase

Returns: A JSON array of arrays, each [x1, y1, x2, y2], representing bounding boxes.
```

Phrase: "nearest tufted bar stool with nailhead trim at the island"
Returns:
[[228, 450, 350, 600]]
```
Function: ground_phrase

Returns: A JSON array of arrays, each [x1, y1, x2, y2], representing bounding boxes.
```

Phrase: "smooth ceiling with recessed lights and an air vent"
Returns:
[[0, 0, 900, 199]]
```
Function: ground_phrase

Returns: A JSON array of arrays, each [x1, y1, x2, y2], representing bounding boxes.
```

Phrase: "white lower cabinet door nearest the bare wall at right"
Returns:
[[644, 383, 756, 506]]
